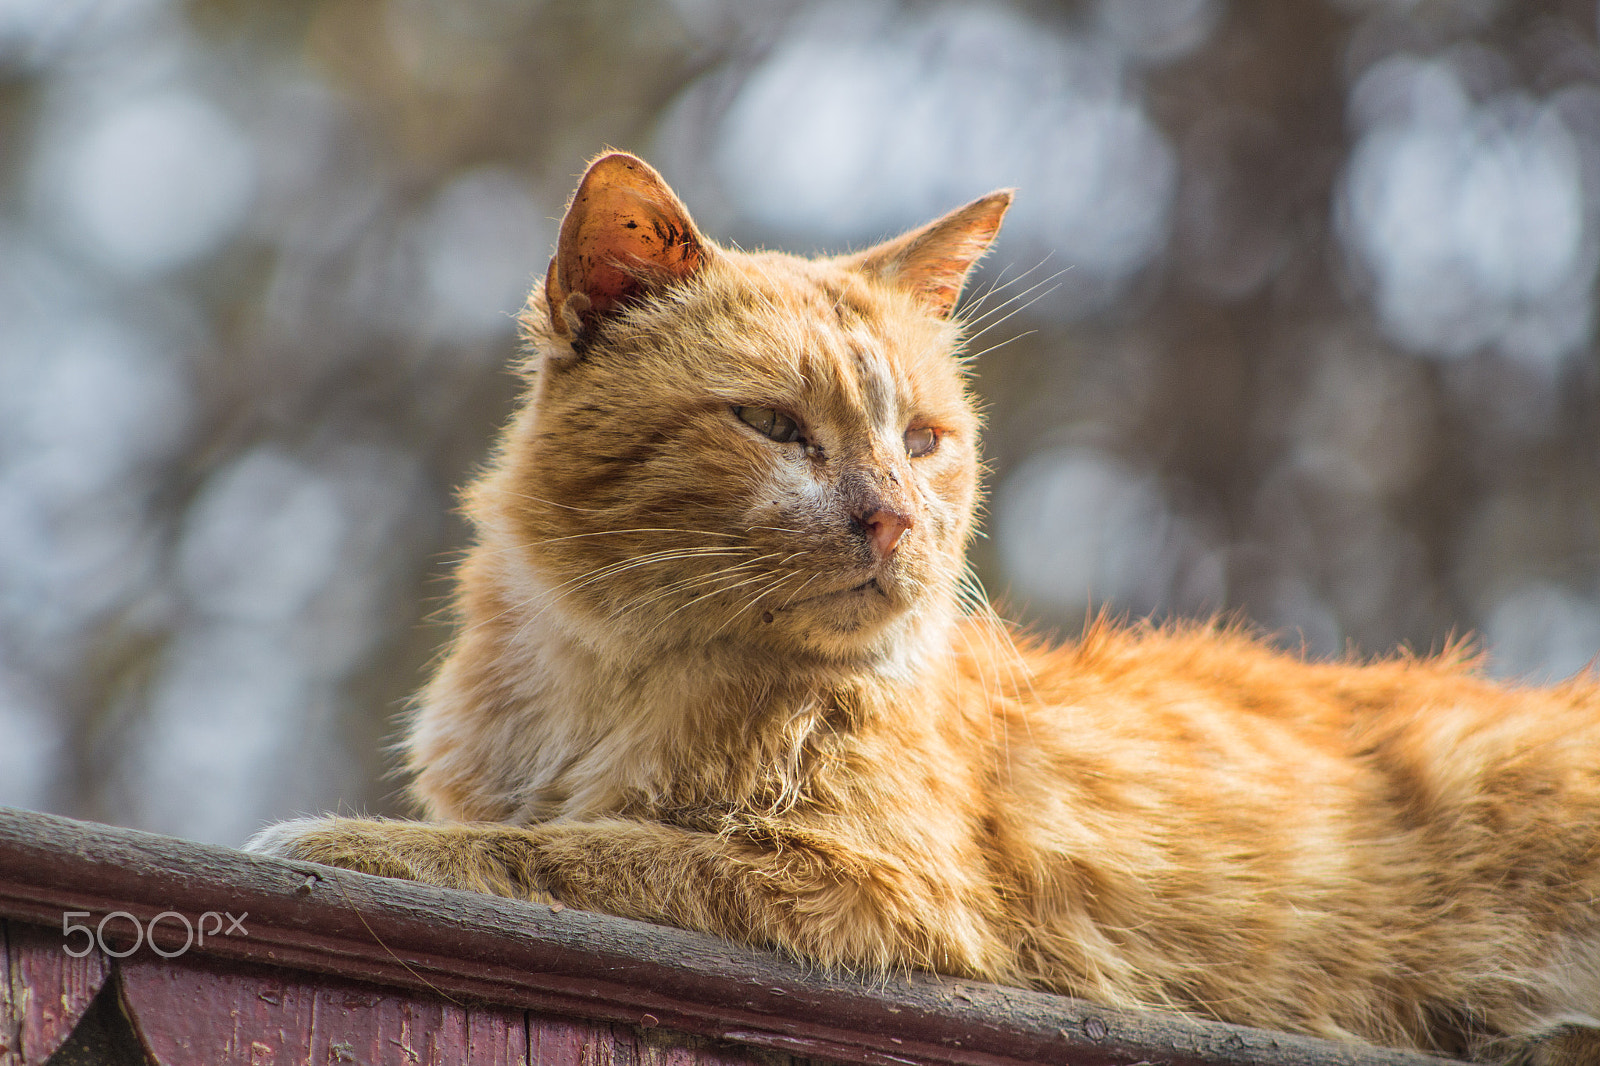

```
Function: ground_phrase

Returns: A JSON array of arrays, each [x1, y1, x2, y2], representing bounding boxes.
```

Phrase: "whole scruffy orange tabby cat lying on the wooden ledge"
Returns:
[[243, 154, 1600, 1053]]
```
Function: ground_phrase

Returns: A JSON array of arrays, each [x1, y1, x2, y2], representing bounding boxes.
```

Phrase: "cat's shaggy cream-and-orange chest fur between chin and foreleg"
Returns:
[[411, 531, 973, 831]]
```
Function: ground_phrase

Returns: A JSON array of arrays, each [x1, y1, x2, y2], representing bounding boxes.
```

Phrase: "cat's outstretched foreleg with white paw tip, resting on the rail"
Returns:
[[248, 818, 1010, 980]]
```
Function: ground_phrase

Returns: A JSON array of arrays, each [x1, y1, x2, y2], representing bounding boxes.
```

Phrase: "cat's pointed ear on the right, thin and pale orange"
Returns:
[[842, 189, 1013, 319]]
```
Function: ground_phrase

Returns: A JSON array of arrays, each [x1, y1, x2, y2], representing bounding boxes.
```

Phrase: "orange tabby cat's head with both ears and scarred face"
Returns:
[[486, 154, 1011, 664]]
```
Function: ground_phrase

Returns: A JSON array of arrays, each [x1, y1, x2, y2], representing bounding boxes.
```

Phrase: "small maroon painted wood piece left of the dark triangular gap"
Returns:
[[0, 922, 110, 1066]]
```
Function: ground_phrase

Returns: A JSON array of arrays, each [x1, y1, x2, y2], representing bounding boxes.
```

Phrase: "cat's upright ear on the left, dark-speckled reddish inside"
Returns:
[[544, 152, 709, 346]]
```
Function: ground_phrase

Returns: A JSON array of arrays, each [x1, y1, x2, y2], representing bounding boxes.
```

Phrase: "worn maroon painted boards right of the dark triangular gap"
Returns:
[[120, 957, 528, 1066]]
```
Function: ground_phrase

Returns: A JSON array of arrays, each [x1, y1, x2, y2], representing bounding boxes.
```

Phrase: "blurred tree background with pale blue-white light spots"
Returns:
[[0, 0, 1600, 844]]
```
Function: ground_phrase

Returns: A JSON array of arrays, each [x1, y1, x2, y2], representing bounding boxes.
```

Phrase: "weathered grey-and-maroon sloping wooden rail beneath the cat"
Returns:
[[0, 808, 1465, 1066]]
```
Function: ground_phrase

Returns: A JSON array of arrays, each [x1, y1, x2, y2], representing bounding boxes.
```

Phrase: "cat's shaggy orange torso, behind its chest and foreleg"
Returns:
[[940, 623, 1600, 1045]]
